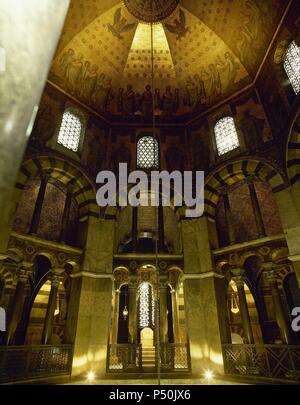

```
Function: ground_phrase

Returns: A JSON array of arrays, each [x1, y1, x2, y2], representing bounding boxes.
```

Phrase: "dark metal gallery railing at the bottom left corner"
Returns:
[[0, 345, 73, 383]]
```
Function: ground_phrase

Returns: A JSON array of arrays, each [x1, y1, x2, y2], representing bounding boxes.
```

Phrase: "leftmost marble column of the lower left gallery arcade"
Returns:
[[6, 262, 33, 345]]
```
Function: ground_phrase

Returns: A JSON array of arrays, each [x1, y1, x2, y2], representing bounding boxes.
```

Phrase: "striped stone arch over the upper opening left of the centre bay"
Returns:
[[15, 155, 100, 220]]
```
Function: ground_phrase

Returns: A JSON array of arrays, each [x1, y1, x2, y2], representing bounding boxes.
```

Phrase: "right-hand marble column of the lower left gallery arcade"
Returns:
[[41, 270, 63, 345]]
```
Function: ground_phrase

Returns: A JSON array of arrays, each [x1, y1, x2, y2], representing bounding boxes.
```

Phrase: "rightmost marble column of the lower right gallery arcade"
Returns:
[[265, 270, 292, 344]]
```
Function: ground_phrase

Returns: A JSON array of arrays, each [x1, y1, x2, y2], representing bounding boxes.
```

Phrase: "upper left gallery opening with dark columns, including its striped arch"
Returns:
[[13, 156, 99, 247]]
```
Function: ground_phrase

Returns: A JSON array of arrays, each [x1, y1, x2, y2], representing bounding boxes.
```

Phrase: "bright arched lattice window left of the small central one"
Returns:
[[57, 110, 83, 152]]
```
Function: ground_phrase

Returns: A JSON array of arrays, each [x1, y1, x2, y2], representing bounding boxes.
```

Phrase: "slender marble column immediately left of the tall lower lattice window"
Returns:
[[128, 281, 138, 367]]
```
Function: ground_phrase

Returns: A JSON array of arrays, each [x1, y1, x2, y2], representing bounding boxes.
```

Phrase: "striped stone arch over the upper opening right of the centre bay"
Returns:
[[204, 158, 287, 220]]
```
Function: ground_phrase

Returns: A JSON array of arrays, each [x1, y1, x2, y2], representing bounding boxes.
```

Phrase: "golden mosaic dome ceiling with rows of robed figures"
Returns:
[[49, 0, 288, 115]]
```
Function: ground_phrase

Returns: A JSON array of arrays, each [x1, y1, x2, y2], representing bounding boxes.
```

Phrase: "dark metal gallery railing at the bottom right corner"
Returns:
[[223, 344, 300, 380]]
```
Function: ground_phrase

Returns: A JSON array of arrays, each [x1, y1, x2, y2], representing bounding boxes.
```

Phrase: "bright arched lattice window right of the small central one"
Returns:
[[214, 117, 239, 156]]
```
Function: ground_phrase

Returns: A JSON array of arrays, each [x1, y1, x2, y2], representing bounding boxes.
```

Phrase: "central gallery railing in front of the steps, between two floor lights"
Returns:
[[107, 343, 191, 373]]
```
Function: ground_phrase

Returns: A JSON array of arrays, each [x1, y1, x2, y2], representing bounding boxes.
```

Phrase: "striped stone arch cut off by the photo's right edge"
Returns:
[[286, 107, 300, 185]]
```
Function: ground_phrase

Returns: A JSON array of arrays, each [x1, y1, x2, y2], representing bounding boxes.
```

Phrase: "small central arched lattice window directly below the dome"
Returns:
[[137, 136, 159, 169]]
